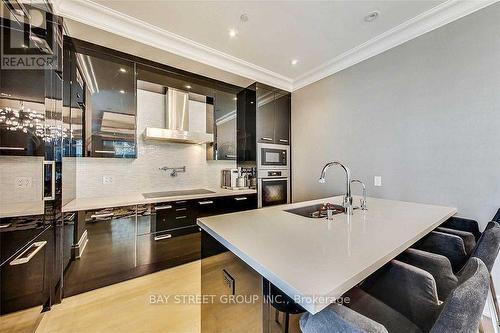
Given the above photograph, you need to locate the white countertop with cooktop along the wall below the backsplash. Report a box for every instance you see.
[63,188,257,212]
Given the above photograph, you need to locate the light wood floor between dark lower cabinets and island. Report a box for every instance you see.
[37,261,201,333]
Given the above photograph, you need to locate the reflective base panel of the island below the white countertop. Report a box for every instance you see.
[201,230,300,333]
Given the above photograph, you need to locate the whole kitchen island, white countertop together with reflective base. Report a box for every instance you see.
[198,196,456,332]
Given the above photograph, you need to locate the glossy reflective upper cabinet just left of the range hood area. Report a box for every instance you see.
[66,40,137,158]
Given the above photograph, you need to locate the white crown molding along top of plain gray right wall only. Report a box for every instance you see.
[292,0,499,90]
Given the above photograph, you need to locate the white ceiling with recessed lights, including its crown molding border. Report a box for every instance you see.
[54,0,492,90]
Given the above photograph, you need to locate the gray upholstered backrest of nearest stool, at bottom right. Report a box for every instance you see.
[431,258,490,333]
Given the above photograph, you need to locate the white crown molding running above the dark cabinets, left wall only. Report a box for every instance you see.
[54,0,293,91]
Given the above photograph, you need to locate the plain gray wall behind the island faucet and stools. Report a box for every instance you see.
[292,4,500,225]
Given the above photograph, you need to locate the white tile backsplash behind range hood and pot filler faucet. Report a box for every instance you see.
[72,90,236,198]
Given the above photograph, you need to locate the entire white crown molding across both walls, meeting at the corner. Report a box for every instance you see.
[54,0,500,91]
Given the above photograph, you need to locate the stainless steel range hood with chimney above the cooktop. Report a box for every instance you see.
[144,87,214,144]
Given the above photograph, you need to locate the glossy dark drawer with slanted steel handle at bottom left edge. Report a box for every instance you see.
[0,227,54,314]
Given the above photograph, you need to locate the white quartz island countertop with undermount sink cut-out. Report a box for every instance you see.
[198,197,457,314]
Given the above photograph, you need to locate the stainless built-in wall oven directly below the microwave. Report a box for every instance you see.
[257,169,290,208]
